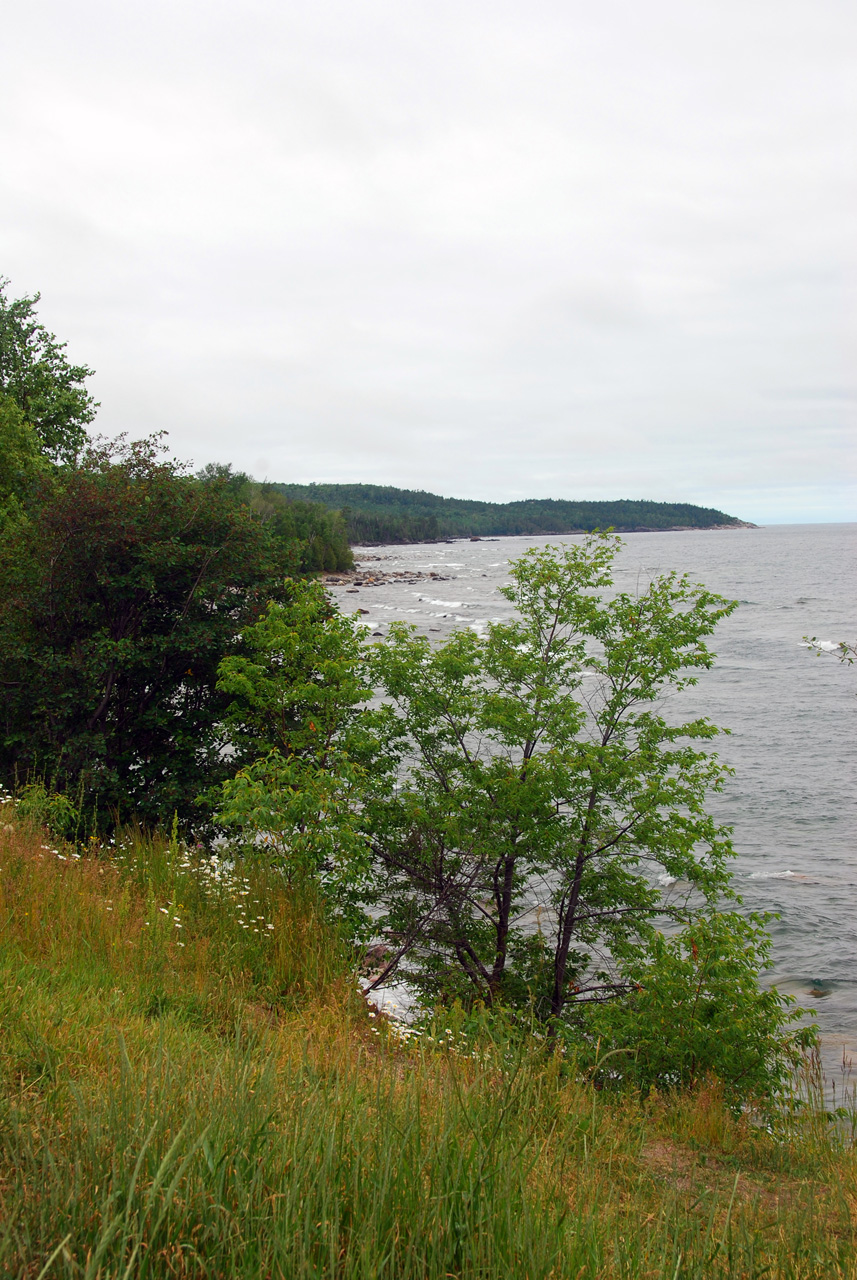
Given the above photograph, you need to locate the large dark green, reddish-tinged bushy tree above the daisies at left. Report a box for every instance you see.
[0,440,295,822]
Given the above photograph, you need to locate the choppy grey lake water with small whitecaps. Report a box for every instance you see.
[331,525,857,1070]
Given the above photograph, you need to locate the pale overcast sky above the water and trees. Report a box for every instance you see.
[0,0,857,524]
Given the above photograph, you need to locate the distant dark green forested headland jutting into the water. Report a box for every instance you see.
[267,484,746,545]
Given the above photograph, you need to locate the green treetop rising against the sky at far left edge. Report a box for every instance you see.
[0,276,98,463]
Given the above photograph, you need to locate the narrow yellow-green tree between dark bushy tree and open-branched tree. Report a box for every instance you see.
[216,581,371,934]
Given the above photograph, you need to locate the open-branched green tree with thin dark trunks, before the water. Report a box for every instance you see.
[365,535,734,1021]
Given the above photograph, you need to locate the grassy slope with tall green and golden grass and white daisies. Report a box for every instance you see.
[0,805,857,1280]
